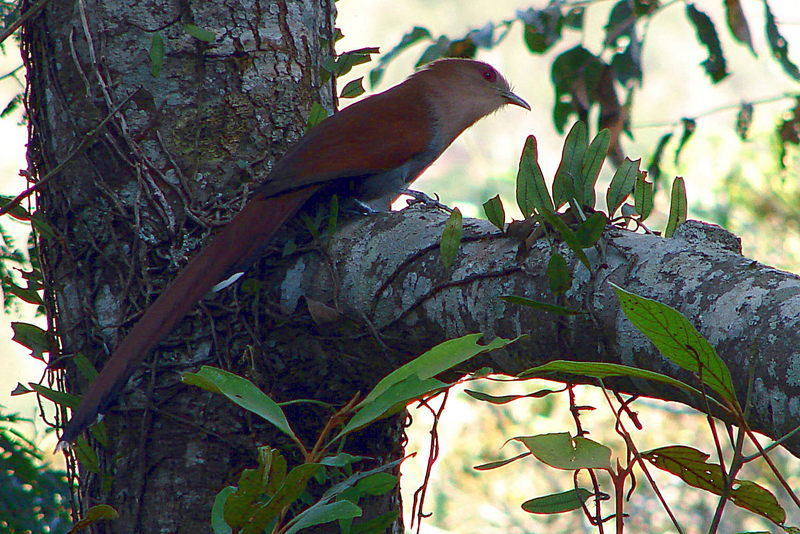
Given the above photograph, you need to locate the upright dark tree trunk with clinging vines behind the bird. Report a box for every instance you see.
[22,0,410,533]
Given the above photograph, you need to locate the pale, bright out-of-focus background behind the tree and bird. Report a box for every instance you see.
[0,0,800,533]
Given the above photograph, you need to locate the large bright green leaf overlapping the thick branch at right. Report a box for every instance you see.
[611,284,737,406]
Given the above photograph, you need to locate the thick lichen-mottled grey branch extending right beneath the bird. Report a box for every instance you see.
[274,209,800,456]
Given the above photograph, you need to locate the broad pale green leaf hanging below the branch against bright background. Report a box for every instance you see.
[513,432,611,471]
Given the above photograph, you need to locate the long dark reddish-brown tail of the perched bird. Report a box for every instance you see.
[56,186,318,450]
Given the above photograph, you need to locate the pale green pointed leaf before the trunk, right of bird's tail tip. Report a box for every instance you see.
[181,365,300,443]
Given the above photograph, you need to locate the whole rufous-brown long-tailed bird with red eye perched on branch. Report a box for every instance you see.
[58,59,530,449]
